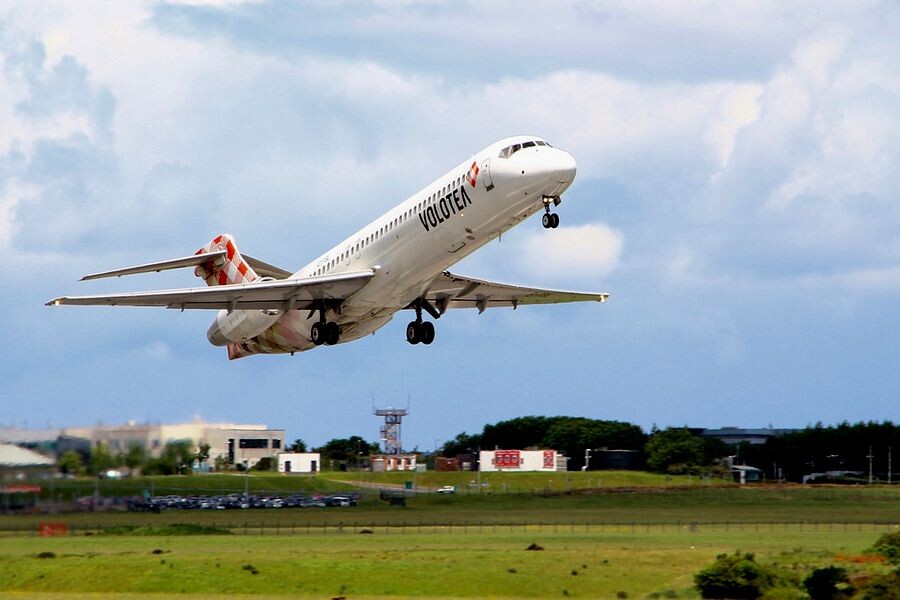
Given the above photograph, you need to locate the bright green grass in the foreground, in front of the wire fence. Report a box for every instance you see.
[0,525,884,598]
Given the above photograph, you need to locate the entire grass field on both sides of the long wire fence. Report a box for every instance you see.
[0,486,900,600]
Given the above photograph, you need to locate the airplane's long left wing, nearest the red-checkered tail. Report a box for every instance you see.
[47,269,375,310]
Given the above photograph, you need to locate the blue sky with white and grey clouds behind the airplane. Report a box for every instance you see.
[0,0,900,450]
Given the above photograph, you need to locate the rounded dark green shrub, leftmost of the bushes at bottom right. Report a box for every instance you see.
[694,552,775,600]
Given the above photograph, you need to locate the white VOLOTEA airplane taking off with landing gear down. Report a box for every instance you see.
[47,136,608,360]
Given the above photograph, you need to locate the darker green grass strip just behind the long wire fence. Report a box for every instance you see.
[0,486,900,532]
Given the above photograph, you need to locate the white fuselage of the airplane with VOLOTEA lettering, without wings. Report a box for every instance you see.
[225,136,575,357]
